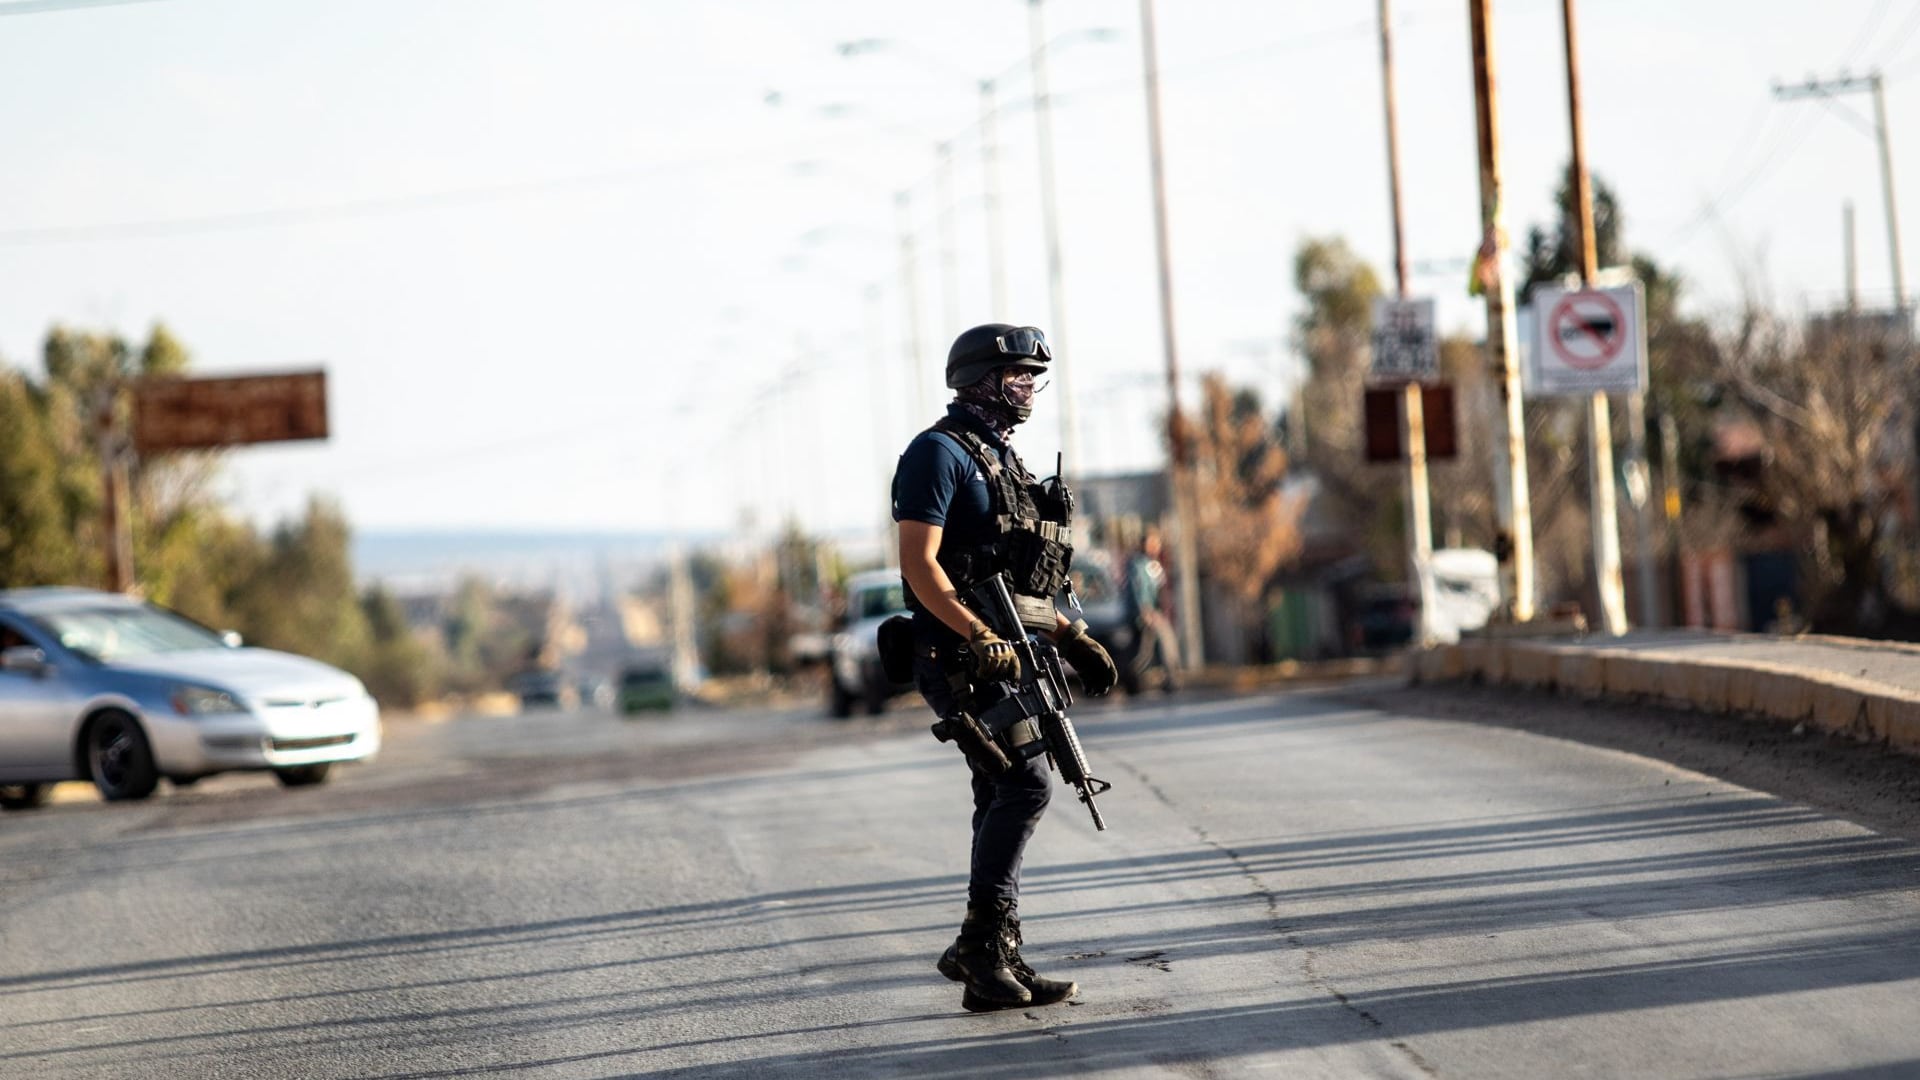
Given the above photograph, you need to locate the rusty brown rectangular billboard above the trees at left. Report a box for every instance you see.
[132,371,326,454]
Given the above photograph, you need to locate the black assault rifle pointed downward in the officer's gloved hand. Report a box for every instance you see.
[973,575,1114,832]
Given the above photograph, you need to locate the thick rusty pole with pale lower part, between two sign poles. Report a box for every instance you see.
[1467,0,1534,623]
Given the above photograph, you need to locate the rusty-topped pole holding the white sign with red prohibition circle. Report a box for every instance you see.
[1561,0,1626,636]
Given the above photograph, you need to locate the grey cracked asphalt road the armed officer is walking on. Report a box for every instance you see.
[0,694,1920,1078]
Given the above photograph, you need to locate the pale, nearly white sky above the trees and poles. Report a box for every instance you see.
[0,0,1920,530]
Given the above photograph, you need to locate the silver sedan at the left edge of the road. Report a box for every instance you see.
[0,588,380,809]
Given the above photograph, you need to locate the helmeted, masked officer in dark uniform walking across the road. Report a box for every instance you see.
[893,323,1119,1013]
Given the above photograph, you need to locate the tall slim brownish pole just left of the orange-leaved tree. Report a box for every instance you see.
[1140,0,1206,669]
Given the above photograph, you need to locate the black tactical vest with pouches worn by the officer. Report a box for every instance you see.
[906,417,1073,630]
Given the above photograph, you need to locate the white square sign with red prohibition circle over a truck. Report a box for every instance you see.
[1526,282,1647,398]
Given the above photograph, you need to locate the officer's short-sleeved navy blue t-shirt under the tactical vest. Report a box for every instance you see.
[893,405,1012,642]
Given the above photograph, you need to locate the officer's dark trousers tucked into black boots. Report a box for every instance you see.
[914,650,1054,905]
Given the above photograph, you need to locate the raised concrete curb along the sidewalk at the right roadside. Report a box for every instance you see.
[1407,638,1920,755]
